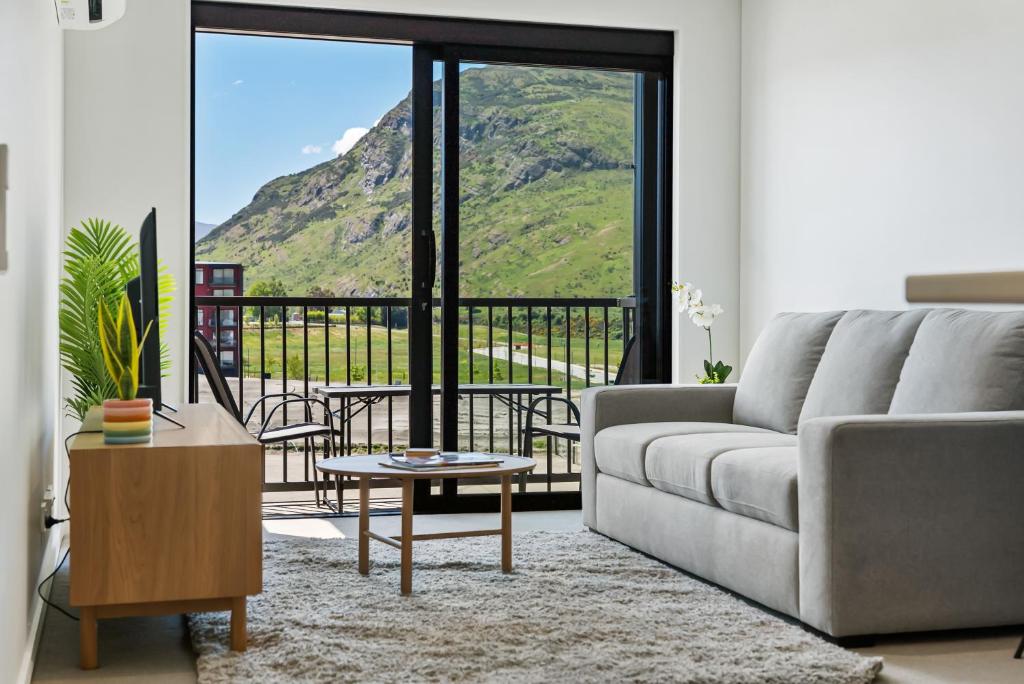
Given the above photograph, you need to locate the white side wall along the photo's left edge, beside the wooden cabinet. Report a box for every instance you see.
[0,0,61,682]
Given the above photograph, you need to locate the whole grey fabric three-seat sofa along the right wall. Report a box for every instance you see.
[582,309,1024,637]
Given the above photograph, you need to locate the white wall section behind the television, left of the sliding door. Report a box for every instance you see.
[64,0,190,402]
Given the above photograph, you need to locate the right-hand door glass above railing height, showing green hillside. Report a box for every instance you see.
[459,65,635,297]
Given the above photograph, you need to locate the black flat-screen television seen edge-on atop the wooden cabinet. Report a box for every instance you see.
[127,209,164,411]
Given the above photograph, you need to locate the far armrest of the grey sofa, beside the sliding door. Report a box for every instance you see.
[580,384,736,527]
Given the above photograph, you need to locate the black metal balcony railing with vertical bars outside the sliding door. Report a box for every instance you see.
[193,296,635,499]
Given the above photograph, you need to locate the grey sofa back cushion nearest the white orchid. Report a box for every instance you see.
[732,311,843,434]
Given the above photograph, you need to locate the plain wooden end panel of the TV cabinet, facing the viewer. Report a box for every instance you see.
[71,444,262,605]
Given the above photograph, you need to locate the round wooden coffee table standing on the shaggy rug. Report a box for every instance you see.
[316,455,537,594]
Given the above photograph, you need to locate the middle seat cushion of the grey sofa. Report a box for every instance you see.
[645,431,797,506]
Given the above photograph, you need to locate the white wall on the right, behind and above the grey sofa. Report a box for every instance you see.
[740,0,1024,356]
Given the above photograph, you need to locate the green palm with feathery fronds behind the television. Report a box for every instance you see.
[59,219,174,420]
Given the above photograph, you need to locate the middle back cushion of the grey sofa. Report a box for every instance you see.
[800,309,928,422]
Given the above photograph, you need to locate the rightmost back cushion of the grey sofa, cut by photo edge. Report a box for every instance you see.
[889,309,1024,414]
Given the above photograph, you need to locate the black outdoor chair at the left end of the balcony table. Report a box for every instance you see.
[193,332,341,508]
